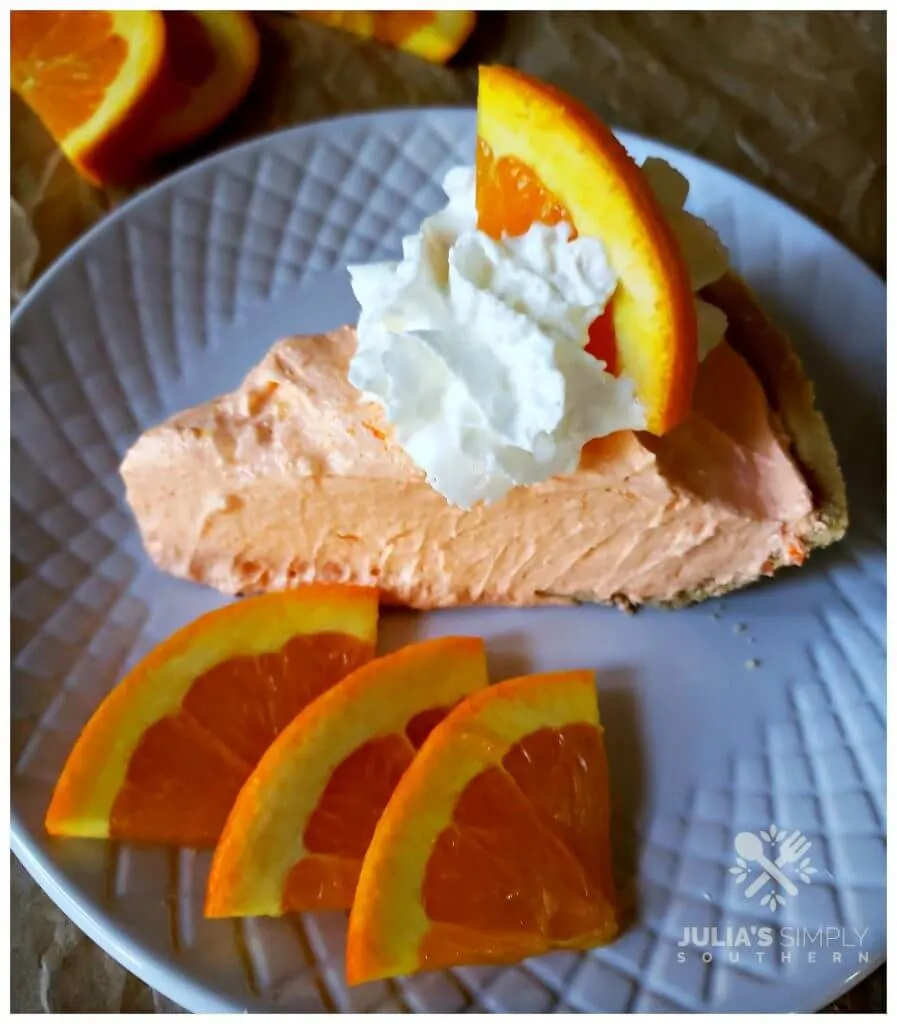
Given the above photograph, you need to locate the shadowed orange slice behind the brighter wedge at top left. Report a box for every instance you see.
[143,10,259,156]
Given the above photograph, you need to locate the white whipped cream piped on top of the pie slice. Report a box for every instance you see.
[349,161,726,508]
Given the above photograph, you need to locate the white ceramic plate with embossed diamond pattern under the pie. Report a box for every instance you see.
[12,110,885,1012]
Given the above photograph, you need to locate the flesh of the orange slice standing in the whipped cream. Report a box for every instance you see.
[476,138,618,377]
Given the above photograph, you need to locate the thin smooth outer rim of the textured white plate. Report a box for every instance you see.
[10,105,887,1013]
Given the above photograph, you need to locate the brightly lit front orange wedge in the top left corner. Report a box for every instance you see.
[10,10,165,180]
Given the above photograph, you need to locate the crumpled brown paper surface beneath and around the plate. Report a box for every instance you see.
[11,12,885,1012]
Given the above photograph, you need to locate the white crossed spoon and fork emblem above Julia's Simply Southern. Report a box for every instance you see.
[729,824,816,910]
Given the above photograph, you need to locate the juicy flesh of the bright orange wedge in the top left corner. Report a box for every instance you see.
[10,10,128,138]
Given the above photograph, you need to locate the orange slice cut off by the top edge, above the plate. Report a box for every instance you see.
[297,10,476,63]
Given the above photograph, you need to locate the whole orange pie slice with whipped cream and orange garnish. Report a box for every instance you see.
[122,68,847,608]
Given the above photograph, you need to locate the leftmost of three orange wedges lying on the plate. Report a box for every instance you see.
[45,585,378,847]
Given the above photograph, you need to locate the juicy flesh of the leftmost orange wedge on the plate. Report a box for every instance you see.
[110,633,374,846]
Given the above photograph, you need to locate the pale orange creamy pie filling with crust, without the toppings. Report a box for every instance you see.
[122,280,845,608]
